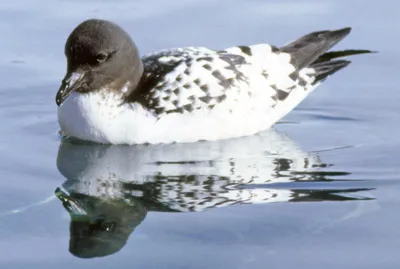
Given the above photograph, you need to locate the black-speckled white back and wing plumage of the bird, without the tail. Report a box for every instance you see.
[127,44,315,117]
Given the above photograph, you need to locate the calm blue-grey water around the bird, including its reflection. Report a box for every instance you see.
[0,0,400,269]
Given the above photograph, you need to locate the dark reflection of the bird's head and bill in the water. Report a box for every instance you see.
[56,189,147,258]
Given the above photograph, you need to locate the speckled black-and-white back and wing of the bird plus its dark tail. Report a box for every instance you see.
[128,28,370,119]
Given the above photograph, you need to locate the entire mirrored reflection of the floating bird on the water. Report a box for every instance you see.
[56,130,369,258]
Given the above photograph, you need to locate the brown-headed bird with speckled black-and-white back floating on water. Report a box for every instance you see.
[56,19,372,145]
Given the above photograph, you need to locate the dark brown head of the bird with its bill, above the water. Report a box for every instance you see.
[56,19,143,106]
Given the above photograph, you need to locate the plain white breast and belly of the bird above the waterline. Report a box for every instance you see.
[58,81,318,144]
